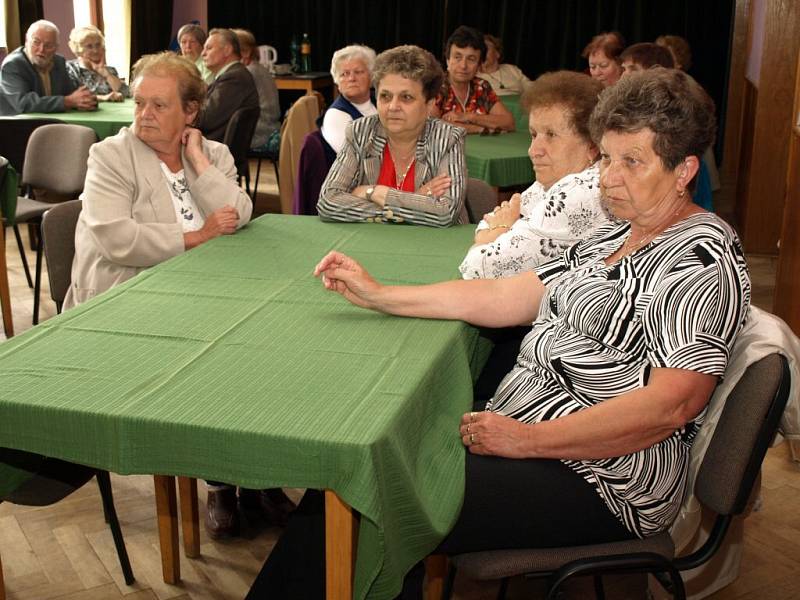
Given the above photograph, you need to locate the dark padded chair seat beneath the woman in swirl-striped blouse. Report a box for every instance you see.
[451,533,675,579]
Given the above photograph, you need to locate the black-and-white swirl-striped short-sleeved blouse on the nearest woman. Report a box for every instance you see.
[487,213,750,537]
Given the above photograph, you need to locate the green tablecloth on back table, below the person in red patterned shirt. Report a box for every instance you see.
[464,131,536,187]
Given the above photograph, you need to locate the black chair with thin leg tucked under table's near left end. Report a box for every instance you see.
[0,448,135,597]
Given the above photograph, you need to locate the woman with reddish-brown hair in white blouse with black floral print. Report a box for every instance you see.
[459,71,609,279]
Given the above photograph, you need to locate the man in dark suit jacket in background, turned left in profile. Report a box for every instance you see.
[197,29,259,142]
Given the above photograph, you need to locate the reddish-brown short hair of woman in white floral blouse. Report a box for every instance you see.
[520,71,603,144]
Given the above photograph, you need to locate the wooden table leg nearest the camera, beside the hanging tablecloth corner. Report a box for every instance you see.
[325,490,358,600]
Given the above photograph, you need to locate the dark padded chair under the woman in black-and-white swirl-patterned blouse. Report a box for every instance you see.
[443,354,790,600]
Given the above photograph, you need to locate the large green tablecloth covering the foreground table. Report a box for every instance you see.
[0,215,487,598]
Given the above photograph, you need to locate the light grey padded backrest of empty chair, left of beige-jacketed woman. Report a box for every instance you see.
[22,123,97,198]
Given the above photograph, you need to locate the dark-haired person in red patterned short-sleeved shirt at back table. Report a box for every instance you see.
[430,25,514,133]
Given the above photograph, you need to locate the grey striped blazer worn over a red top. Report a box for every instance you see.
[317,115,467,227]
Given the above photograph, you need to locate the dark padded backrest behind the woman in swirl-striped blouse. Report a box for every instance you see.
[695,354,790,515]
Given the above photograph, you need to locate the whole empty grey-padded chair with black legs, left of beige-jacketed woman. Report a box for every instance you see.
[6,123,97,325]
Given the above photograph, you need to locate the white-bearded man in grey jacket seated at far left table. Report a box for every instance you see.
[0,20,97,116]
